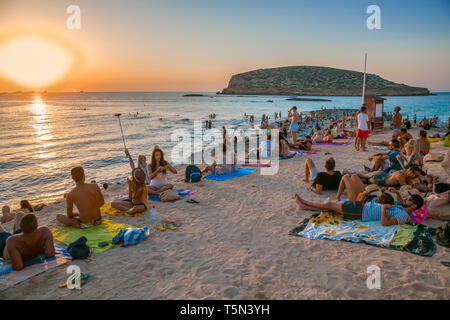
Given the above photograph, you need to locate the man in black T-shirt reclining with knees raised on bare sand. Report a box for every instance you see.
[303,158,342,194]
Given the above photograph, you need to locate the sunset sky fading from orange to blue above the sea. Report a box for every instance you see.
[0,0,450,92]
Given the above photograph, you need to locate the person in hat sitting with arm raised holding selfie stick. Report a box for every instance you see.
[111,149,148,214]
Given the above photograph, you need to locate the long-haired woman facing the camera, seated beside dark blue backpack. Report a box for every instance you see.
[148,148,177,195]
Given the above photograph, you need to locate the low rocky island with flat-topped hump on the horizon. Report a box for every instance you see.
[220,66,430,96]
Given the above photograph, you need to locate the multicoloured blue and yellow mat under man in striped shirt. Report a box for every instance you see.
[289,213,436,257]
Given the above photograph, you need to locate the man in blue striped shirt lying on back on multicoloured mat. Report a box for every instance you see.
[294,193,423,226]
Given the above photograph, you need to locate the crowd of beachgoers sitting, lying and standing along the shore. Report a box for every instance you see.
[0,105,450,270]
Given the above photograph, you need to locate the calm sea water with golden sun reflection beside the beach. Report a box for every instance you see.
[0,92,450,206]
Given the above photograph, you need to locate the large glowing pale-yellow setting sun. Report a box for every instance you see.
[0,35,74,88]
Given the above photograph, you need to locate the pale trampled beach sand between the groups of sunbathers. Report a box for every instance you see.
[0,128,450,300]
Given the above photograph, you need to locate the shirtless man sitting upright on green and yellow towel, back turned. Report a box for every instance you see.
[56,167,105,228]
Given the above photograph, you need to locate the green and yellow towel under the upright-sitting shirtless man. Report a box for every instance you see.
[51,219,133,253]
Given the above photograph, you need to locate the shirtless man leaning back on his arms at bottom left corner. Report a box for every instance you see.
[0,213,55,270]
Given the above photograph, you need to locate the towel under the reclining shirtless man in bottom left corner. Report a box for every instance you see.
[0,245,72,291]
